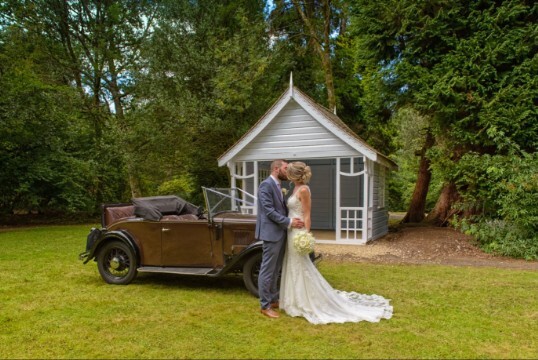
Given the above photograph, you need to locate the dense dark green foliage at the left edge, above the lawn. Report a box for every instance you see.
[0,27,119,213]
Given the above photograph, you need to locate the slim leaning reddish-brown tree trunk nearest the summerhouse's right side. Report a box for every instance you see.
[402,130,435,223]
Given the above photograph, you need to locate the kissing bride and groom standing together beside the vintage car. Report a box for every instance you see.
[256,160,392,324]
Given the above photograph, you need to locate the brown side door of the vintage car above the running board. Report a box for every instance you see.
[161,220,212,267]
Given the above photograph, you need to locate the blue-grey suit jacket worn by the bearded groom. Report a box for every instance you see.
[256,176,291,242]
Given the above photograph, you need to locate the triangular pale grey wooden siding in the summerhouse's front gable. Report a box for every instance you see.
[235,99,360,161]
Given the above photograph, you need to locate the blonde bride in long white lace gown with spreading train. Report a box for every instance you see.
[279,162,392,324]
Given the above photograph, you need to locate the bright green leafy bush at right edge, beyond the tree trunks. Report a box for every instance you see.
[456,153,538,260]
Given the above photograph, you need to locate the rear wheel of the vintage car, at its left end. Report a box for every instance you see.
[97,241,137,285]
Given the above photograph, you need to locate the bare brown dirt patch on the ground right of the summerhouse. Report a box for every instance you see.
[316,226,538,270]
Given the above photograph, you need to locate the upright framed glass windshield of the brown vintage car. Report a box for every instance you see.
[202,187,256,219]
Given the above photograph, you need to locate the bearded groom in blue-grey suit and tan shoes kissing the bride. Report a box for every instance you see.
[256,160,304,318]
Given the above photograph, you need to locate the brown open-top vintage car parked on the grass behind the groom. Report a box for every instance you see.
[79,188,262,296]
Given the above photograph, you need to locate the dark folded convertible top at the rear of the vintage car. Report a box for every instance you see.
[131,195,202,221]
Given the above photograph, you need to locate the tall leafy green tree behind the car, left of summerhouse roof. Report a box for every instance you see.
[136,0,280,202]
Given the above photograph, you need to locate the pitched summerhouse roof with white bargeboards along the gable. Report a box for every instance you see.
[218,84,398,170]
